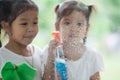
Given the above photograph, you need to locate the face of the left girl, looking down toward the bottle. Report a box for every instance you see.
[8,10,38,45]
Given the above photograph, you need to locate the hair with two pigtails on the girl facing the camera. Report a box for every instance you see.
[55,0,93,22]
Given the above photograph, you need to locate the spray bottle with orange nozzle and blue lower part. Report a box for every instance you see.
[52,31,68,80]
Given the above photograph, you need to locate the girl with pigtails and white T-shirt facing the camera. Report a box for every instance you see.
[52,0,103,80]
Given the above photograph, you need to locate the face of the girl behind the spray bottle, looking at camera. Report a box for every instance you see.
[59,10,88,42]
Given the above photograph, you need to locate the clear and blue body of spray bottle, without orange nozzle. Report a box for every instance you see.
[55,46,68,80]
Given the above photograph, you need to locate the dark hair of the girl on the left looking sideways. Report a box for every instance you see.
[0,0,38,46]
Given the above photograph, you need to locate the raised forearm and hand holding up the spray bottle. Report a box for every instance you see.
[42,39,58,80]
